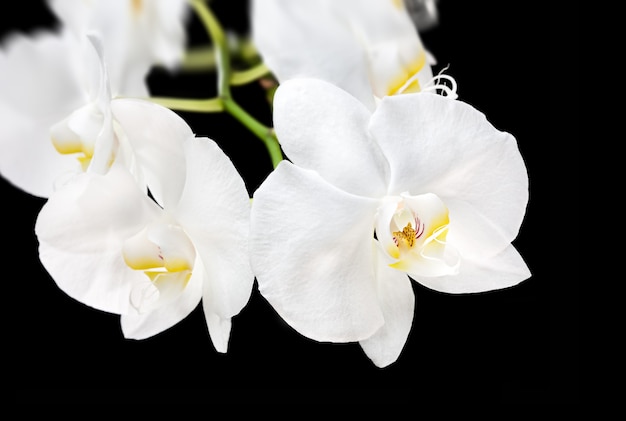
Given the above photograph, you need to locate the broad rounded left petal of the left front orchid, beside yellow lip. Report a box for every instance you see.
[35,162,160,314]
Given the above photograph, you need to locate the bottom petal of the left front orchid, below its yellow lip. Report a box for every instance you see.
[121,264,203,339]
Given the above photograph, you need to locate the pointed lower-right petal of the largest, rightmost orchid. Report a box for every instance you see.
[409,246,531,293]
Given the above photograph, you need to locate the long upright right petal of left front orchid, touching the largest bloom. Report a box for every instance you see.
[172,138,254,319]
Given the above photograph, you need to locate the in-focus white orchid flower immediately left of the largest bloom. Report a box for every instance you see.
[35,99,254,352]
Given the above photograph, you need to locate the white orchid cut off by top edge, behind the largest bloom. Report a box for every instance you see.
[251,0,434,108]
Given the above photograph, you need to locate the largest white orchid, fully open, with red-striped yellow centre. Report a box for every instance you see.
[251,79,530,367]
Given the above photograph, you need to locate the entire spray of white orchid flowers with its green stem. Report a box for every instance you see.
[0,0,531,368]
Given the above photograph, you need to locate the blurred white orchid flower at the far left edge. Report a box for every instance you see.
[0,27,173,198]
